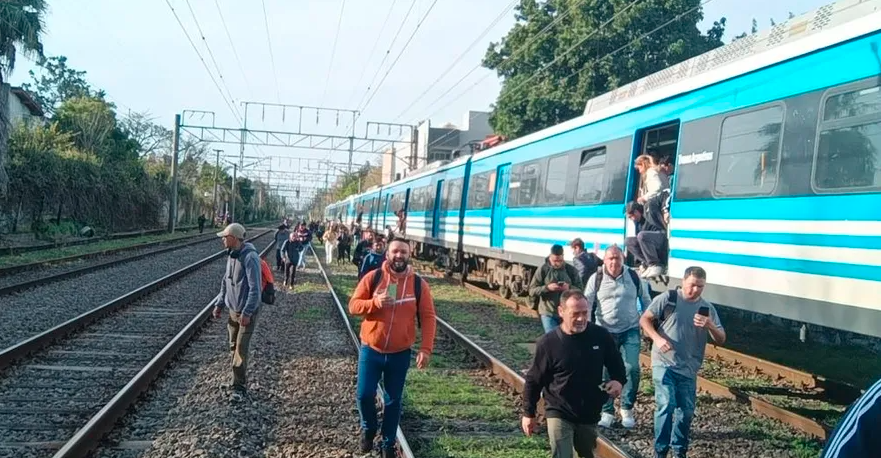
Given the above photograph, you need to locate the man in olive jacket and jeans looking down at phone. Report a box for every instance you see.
[529,245,584,333]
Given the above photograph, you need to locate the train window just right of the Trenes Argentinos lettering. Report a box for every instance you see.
[714,105,784,197]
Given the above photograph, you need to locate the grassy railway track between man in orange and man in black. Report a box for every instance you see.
[316,247,631,458]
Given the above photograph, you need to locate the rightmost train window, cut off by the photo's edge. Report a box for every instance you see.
[813,83,881,190]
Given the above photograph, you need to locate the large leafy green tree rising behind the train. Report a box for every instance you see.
[483,0,725,138]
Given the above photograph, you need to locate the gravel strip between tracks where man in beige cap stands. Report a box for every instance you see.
[94,245,370,458]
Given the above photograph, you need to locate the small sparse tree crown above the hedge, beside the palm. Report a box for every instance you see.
[22,56,106,116]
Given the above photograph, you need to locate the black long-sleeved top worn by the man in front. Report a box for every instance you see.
[523,324,627,425]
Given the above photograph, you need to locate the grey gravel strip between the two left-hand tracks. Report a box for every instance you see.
[0,232,268,354]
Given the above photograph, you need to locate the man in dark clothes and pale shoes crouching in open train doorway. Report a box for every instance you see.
[624,201,668,278]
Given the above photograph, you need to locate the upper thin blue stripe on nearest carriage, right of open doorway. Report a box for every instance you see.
[672,231,881,250]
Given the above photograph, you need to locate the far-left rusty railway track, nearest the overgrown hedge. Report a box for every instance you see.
[0,234,216,296]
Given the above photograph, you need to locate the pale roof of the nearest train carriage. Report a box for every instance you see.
[472,0,881,162]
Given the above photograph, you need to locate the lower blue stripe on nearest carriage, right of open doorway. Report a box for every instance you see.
[670,249,881,282]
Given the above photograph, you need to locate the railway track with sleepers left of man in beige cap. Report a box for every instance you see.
[0,234,272,457]
